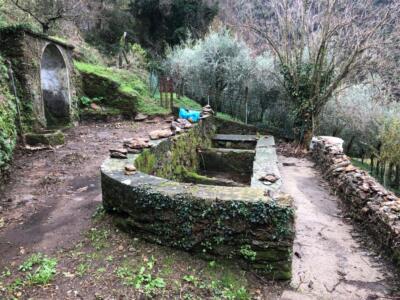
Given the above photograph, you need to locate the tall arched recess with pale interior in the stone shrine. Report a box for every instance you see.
[40,44,71,127]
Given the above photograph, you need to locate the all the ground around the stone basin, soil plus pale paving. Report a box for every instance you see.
[0,119,396,299]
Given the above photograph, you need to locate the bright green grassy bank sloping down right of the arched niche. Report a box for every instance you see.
[75,61,170,115]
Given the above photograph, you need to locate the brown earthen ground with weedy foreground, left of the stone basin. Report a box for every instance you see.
[0,119,285,299]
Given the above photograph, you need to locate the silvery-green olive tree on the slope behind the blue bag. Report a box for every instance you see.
[165,29,254,115]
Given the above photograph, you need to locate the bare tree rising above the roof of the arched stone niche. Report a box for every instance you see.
[9,0,82,33]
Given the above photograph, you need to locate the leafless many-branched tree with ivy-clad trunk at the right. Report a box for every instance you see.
[232,0,400,146]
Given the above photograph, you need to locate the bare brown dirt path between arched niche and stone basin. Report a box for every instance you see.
[0,120,168,269]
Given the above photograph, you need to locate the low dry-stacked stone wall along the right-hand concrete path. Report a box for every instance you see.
[312,137,400,264]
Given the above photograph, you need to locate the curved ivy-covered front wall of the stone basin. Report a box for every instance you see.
[101,118,294,280]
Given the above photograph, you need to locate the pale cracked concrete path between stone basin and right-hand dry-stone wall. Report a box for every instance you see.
[280,156,399,299]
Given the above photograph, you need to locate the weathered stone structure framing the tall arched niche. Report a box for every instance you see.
[0,26,79,132]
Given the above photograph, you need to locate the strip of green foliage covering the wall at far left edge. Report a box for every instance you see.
[0,56,17,182]
